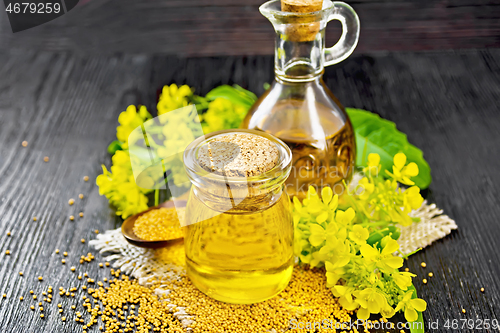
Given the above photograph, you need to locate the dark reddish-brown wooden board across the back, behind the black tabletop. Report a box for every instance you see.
[0,0,500,57]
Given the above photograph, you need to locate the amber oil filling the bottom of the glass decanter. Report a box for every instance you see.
[242,99,356,199]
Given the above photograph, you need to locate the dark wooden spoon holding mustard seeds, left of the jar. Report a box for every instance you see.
[122,200,186,249]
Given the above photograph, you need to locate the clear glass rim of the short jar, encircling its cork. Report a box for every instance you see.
[183,129,292,185]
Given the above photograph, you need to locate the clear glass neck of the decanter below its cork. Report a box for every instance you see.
[274,29,325,82]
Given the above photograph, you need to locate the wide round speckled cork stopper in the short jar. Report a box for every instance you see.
[198,133,279,177]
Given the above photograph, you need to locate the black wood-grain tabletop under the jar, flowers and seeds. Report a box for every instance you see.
[0,49,500,333]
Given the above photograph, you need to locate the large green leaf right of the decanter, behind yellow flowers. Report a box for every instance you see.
[346,108,432,189]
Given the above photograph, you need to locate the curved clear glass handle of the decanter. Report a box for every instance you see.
[325,2,359,66]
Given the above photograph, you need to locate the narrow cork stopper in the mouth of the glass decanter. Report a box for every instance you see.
[281,0,323,42]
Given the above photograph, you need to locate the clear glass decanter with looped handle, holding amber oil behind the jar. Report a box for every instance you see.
[242,0,359,198]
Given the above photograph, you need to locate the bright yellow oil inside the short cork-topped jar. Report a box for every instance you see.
[184,192,293,304]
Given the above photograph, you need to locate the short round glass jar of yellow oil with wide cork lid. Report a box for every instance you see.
[184,130,293,304]
